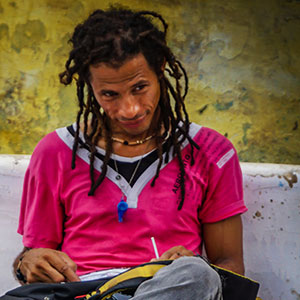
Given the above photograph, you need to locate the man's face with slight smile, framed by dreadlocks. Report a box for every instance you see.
[90,54,160,139]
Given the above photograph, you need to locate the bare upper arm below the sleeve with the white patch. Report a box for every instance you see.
[203,215,244,275]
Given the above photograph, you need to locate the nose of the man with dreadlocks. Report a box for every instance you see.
[119,94,141,121]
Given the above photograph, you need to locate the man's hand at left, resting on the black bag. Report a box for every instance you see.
[20,248,80,283]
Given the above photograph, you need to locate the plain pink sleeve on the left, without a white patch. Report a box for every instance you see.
[18,133,64,249]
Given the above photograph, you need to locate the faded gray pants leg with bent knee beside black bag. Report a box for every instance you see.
[131,256,222,300]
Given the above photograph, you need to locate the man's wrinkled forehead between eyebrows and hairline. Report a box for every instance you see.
[89,54,156,84]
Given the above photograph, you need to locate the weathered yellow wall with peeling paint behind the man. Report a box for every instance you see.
[0,0,300,164]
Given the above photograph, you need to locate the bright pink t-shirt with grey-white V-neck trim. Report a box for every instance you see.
[18,124,247,275]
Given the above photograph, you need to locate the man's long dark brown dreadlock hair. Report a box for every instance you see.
[59,7,198,210]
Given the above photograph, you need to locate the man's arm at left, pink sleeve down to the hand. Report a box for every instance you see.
[13,132,78,283]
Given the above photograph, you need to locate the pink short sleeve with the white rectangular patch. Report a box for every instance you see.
[199,137,247,223]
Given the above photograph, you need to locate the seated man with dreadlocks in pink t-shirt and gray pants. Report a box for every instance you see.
[14,8,246,299]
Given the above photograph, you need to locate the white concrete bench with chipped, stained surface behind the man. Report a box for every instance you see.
[0,155,300,300]
